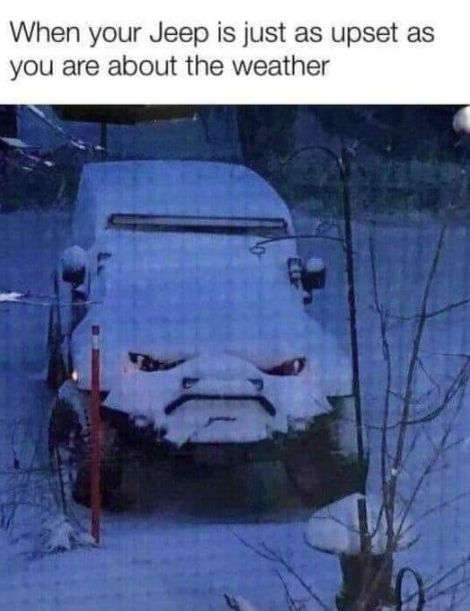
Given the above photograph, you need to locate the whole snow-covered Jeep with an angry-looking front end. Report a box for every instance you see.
[48,161,361,506]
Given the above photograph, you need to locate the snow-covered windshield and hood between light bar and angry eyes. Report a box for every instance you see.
[75,234,312,366]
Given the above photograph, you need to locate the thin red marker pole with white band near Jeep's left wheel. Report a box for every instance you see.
[90,325,101,543]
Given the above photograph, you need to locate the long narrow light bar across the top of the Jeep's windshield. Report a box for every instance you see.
[107,214,288,237]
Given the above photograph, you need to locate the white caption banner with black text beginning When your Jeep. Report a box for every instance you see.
[0,0,470,104]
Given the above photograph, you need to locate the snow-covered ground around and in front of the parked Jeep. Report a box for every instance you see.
[0,212,470,611]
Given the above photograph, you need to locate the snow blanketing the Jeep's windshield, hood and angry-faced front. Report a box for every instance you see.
[72,230,350,443]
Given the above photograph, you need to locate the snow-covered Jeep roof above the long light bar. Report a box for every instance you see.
[74,160,292,248]
